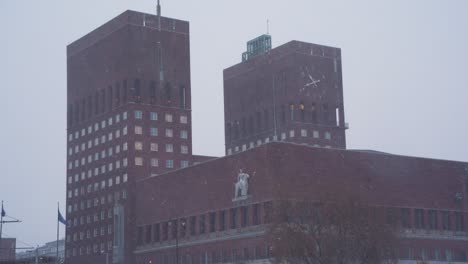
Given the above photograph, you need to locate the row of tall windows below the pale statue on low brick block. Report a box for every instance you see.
[137,202,272,245]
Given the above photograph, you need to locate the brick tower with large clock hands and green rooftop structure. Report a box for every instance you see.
[224,35,347,155]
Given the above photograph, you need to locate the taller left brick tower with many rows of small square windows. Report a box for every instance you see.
[66,8,204,263]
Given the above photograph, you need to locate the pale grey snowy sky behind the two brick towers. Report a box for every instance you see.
[0,0,468,246]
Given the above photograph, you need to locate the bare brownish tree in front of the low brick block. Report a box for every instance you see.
[268,198,398,264]
